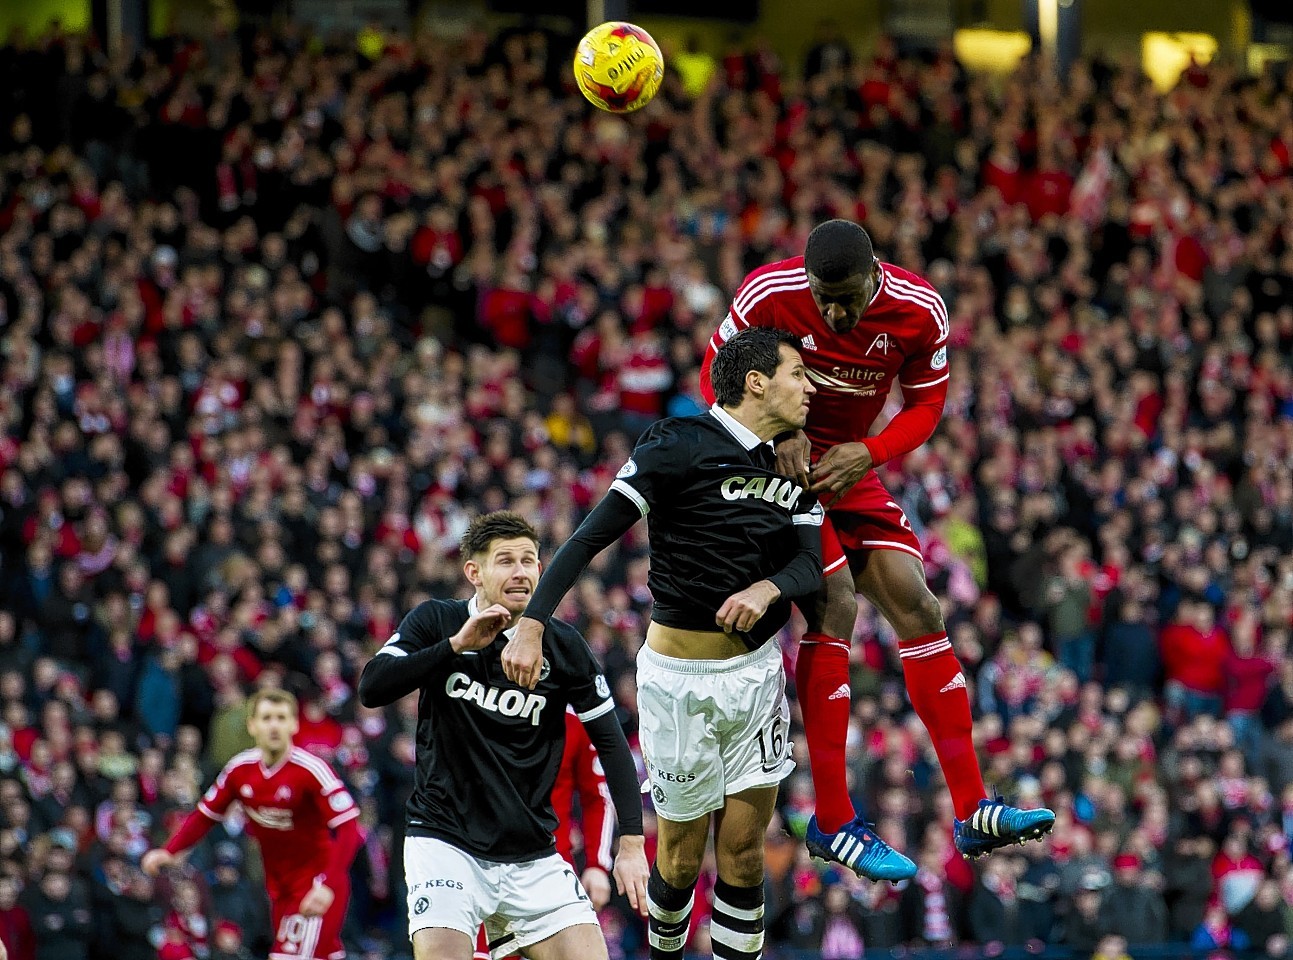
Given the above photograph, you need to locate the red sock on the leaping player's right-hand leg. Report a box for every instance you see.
[905,631,988,820]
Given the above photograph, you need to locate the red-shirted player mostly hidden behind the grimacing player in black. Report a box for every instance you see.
[475,706,615,960]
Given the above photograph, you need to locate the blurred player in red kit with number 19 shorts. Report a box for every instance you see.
[142,690,363,960]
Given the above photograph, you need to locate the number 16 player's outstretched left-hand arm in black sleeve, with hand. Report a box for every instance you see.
[502,492,641,690]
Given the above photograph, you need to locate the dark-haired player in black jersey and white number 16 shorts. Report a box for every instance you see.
[503,327,824,960]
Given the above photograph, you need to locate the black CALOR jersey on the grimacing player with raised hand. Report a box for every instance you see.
[379,598,614,863]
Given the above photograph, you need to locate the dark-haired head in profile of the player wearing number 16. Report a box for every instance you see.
[710,326,817,432]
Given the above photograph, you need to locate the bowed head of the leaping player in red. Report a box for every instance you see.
[804,220,881,334]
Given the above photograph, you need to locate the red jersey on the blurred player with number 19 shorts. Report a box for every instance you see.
[198,747,359,899]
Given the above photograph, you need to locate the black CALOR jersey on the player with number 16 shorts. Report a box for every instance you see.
[610,408,825,646]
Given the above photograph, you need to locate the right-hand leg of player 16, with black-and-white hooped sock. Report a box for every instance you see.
[710,787,777,960]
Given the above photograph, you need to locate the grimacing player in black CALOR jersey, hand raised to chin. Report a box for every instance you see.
[359,511,648,960]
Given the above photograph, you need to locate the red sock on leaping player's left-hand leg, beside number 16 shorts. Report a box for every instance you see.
[795,633,853,833]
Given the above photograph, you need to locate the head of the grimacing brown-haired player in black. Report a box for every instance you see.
[459,510,542,616]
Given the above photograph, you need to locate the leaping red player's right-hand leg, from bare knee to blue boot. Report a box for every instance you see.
[855,550,1055,856]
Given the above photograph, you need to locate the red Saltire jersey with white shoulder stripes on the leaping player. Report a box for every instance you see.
[701,256,950,462]
